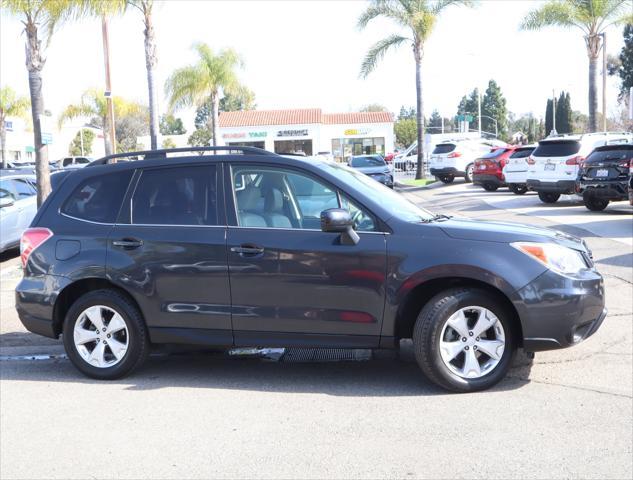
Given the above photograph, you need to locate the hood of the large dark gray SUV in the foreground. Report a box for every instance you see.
[439,218,589,253]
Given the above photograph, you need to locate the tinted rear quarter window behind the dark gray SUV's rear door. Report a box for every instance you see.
[62,170,132,223]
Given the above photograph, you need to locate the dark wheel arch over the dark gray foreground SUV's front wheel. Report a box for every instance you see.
[393,277,523,346]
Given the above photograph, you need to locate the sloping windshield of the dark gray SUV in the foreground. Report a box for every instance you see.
[319,162,435,223]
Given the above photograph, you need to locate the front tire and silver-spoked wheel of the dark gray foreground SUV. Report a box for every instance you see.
[413,288,516,392]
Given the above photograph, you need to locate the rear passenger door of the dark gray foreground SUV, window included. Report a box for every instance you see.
[107,165,233,345]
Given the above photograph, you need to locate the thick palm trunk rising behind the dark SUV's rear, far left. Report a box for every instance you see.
[25,22,51,207]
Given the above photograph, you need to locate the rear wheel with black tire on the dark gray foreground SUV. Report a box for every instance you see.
[63,290,149,380]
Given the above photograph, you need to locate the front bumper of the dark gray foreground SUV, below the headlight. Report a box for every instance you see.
[513,270,607,352]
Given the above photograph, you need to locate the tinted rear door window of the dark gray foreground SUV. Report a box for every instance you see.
[132,165,218,225]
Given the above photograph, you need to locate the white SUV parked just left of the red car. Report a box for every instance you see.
[429,140,491,183]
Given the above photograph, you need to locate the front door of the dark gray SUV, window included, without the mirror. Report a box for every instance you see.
[226,164,386,347]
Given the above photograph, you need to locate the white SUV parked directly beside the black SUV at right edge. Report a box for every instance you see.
[526,132,633,203]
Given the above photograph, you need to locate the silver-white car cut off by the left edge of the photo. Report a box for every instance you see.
[0,172,37,252]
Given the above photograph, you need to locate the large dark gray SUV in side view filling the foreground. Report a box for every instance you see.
[16,147,606,391]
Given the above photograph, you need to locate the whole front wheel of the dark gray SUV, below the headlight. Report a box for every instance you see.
[413,288,516,392]
